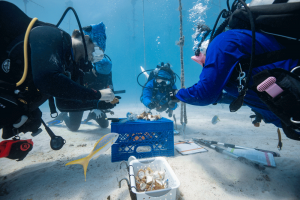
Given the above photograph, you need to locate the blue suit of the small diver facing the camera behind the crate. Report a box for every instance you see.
[141,79,177,110]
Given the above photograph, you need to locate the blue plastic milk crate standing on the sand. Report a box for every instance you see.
[111,118,174,162]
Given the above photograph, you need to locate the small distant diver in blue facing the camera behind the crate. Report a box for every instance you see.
[141,62,177,117]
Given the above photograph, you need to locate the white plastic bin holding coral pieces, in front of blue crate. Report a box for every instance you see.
[129,157,180,200]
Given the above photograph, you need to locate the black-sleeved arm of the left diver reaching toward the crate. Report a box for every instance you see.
[29,26,101,100]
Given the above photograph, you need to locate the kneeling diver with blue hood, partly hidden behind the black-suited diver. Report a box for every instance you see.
[48,22,113,131]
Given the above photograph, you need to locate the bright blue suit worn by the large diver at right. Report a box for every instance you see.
[176,29,298,128]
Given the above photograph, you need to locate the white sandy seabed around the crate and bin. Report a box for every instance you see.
[0,105,300,200]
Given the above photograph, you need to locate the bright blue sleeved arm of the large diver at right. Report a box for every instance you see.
[176,33,245,106]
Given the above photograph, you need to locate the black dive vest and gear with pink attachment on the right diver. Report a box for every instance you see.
[207,0,300,140]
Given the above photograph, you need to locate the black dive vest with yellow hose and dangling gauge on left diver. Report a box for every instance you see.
[0,1,86,150]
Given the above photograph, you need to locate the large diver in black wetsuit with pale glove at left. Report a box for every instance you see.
[0,1,115,143]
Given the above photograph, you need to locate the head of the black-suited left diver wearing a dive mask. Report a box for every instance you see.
[72,30,94,63]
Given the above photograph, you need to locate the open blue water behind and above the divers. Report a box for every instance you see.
[10,0,226,108]
